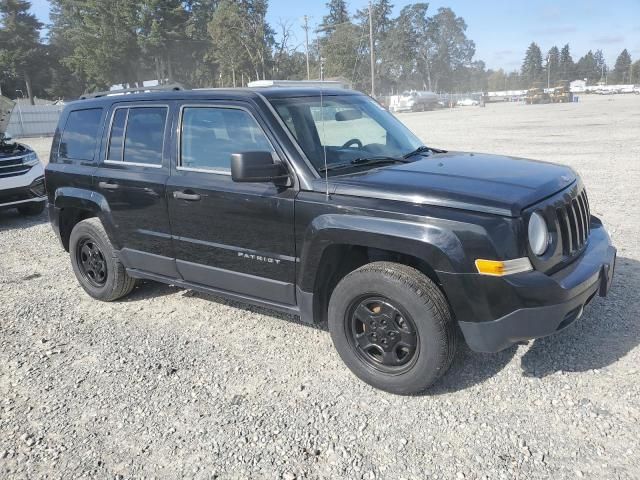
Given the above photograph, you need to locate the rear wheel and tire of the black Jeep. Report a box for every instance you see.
[69,218,136,302]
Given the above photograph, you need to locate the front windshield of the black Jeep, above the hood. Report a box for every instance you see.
[271,95,422,174]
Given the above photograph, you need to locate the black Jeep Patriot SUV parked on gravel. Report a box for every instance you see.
[46,88,616,394]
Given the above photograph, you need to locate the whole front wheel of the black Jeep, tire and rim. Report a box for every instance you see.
[329,262,457,395]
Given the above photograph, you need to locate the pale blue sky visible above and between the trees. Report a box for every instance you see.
[27,0,640,71]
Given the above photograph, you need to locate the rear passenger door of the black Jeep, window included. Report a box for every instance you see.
[94,103,178,277]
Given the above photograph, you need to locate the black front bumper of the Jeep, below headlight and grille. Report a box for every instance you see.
[454,221,616,352]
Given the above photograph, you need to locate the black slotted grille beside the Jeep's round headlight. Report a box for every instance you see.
[556,189,591,255]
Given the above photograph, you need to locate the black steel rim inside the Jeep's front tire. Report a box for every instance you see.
[345,296,419,373]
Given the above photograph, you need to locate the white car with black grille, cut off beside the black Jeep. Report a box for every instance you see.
[0,97,46,215]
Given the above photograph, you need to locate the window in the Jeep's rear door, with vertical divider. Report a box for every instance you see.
[107,107,168,166]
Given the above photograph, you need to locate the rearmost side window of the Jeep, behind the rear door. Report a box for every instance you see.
[58,108,102,161]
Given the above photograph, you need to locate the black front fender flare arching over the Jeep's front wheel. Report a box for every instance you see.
[298,214,470,292]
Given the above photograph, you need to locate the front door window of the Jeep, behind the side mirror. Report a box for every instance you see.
[180,107,273,172]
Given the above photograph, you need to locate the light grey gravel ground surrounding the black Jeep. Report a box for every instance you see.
[0,96,640,479]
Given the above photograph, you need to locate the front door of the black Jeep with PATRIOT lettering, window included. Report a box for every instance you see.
[167,103,296,305]
